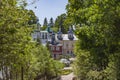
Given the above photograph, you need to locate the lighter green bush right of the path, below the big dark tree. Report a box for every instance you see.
[73,47,92,79]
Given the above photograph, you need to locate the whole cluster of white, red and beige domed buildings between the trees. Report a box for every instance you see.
[32,26,78,59]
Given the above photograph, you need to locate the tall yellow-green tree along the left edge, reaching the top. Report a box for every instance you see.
[0,0,34,80]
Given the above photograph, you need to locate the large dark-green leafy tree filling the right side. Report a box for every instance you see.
[66,0,120,80]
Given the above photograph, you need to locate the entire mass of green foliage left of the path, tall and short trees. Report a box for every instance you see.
[0,0,62,80]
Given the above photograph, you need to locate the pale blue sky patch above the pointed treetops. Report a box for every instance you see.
[26,0,68,25]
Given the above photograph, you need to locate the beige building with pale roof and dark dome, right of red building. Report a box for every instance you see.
[58,28,78,57]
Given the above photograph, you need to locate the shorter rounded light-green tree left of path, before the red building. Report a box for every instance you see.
[33,44,63,80]
